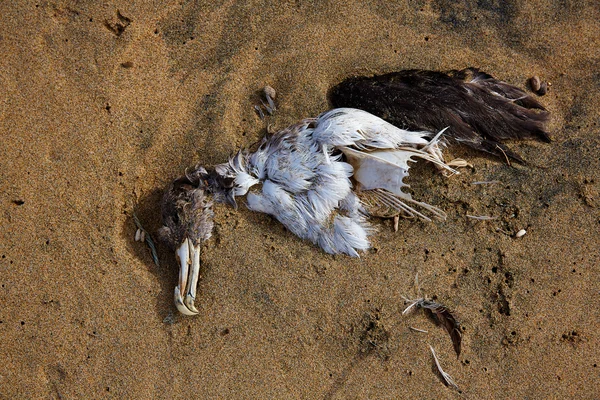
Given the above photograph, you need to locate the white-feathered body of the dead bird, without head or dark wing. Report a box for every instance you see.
[236,108,450,257]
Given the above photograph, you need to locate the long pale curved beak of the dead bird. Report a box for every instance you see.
[174,238,200,315]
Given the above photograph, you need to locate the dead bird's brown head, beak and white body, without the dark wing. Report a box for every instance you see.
[160,69,548,315]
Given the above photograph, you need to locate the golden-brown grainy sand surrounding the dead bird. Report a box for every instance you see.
[0,0,600,399]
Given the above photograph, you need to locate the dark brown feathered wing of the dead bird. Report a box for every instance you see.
[329,68,550,162]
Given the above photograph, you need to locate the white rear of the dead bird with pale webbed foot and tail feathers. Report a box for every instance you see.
[312,108,455,220]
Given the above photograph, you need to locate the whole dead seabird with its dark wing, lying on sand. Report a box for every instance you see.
[160,70,548,315]
